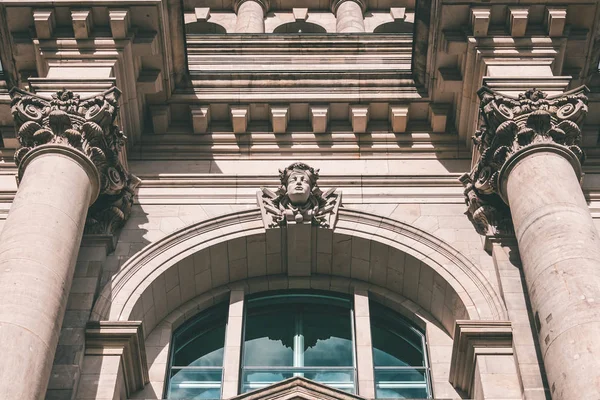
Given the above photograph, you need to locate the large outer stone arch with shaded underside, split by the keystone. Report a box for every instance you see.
[92,209,506,334]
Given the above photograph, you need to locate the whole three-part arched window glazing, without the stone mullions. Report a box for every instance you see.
[167,291,431,399]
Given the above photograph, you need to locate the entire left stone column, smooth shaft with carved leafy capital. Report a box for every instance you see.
[0,88,137,400]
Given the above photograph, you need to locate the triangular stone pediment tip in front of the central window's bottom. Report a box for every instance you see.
[232,377,365,400]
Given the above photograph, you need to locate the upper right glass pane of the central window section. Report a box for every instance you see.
[302,308,353,367]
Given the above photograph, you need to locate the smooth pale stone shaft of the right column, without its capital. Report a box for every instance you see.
[504,146,600,400]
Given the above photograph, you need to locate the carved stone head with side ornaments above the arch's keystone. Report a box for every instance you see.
[256,162,342,229]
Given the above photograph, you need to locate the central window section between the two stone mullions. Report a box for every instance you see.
[241,294,355,393]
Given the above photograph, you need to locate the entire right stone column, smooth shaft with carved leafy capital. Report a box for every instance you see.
[463,87,600,400]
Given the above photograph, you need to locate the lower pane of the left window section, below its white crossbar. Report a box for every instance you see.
[168,369,222,399]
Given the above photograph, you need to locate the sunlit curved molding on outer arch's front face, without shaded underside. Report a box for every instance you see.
[92,209,506,332]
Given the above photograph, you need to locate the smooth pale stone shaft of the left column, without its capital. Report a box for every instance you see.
[0,145,98,400]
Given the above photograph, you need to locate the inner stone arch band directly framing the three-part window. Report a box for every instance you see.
[131,275,460,399]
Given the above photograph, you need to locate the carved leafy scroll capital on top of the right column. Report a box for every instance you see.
[460,86,588,235]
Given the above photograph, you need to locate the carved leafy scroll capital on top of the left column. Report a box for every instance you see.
[10,87,140,234]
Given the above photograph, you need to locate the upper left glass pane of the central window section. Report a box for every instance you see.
[244,309,295,366]
